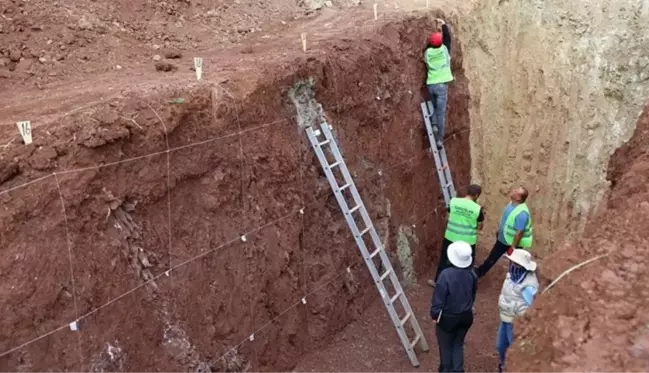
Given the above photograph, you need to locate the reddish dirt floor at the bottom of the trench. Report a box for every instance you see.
[291,258,506,373]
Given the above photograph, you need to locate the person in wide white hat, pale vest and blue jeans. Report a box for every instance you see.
[496,249,539,373]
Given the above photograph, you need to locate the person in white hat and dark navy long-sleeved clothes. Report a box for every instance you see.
[430,241,478,373]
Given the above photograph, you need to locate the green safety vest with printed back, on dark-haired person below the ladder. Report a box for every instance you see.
[444,197,480,245]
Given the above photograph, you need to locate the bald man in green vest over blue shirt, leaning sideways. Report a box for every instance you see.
[476,186,533,277]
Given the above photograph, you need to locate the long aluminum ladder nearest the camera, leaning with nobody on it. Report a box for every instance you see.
[306,122,428,367]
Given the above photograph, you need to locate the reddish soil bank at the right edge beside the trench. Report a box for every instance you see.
[509,101,649,373]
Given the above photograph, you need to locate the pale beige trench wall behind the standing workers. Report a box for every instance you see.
[457,0,649,255]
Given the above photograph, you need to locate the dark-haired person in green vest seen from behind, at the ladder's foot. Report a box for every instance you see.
[427,184,484,286]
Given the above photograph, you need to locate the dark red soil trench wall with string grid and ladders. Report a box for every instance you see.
[0,19,470,372]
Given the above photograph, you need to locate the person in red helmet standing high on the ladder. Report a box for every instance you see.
[424,18,453,149]
